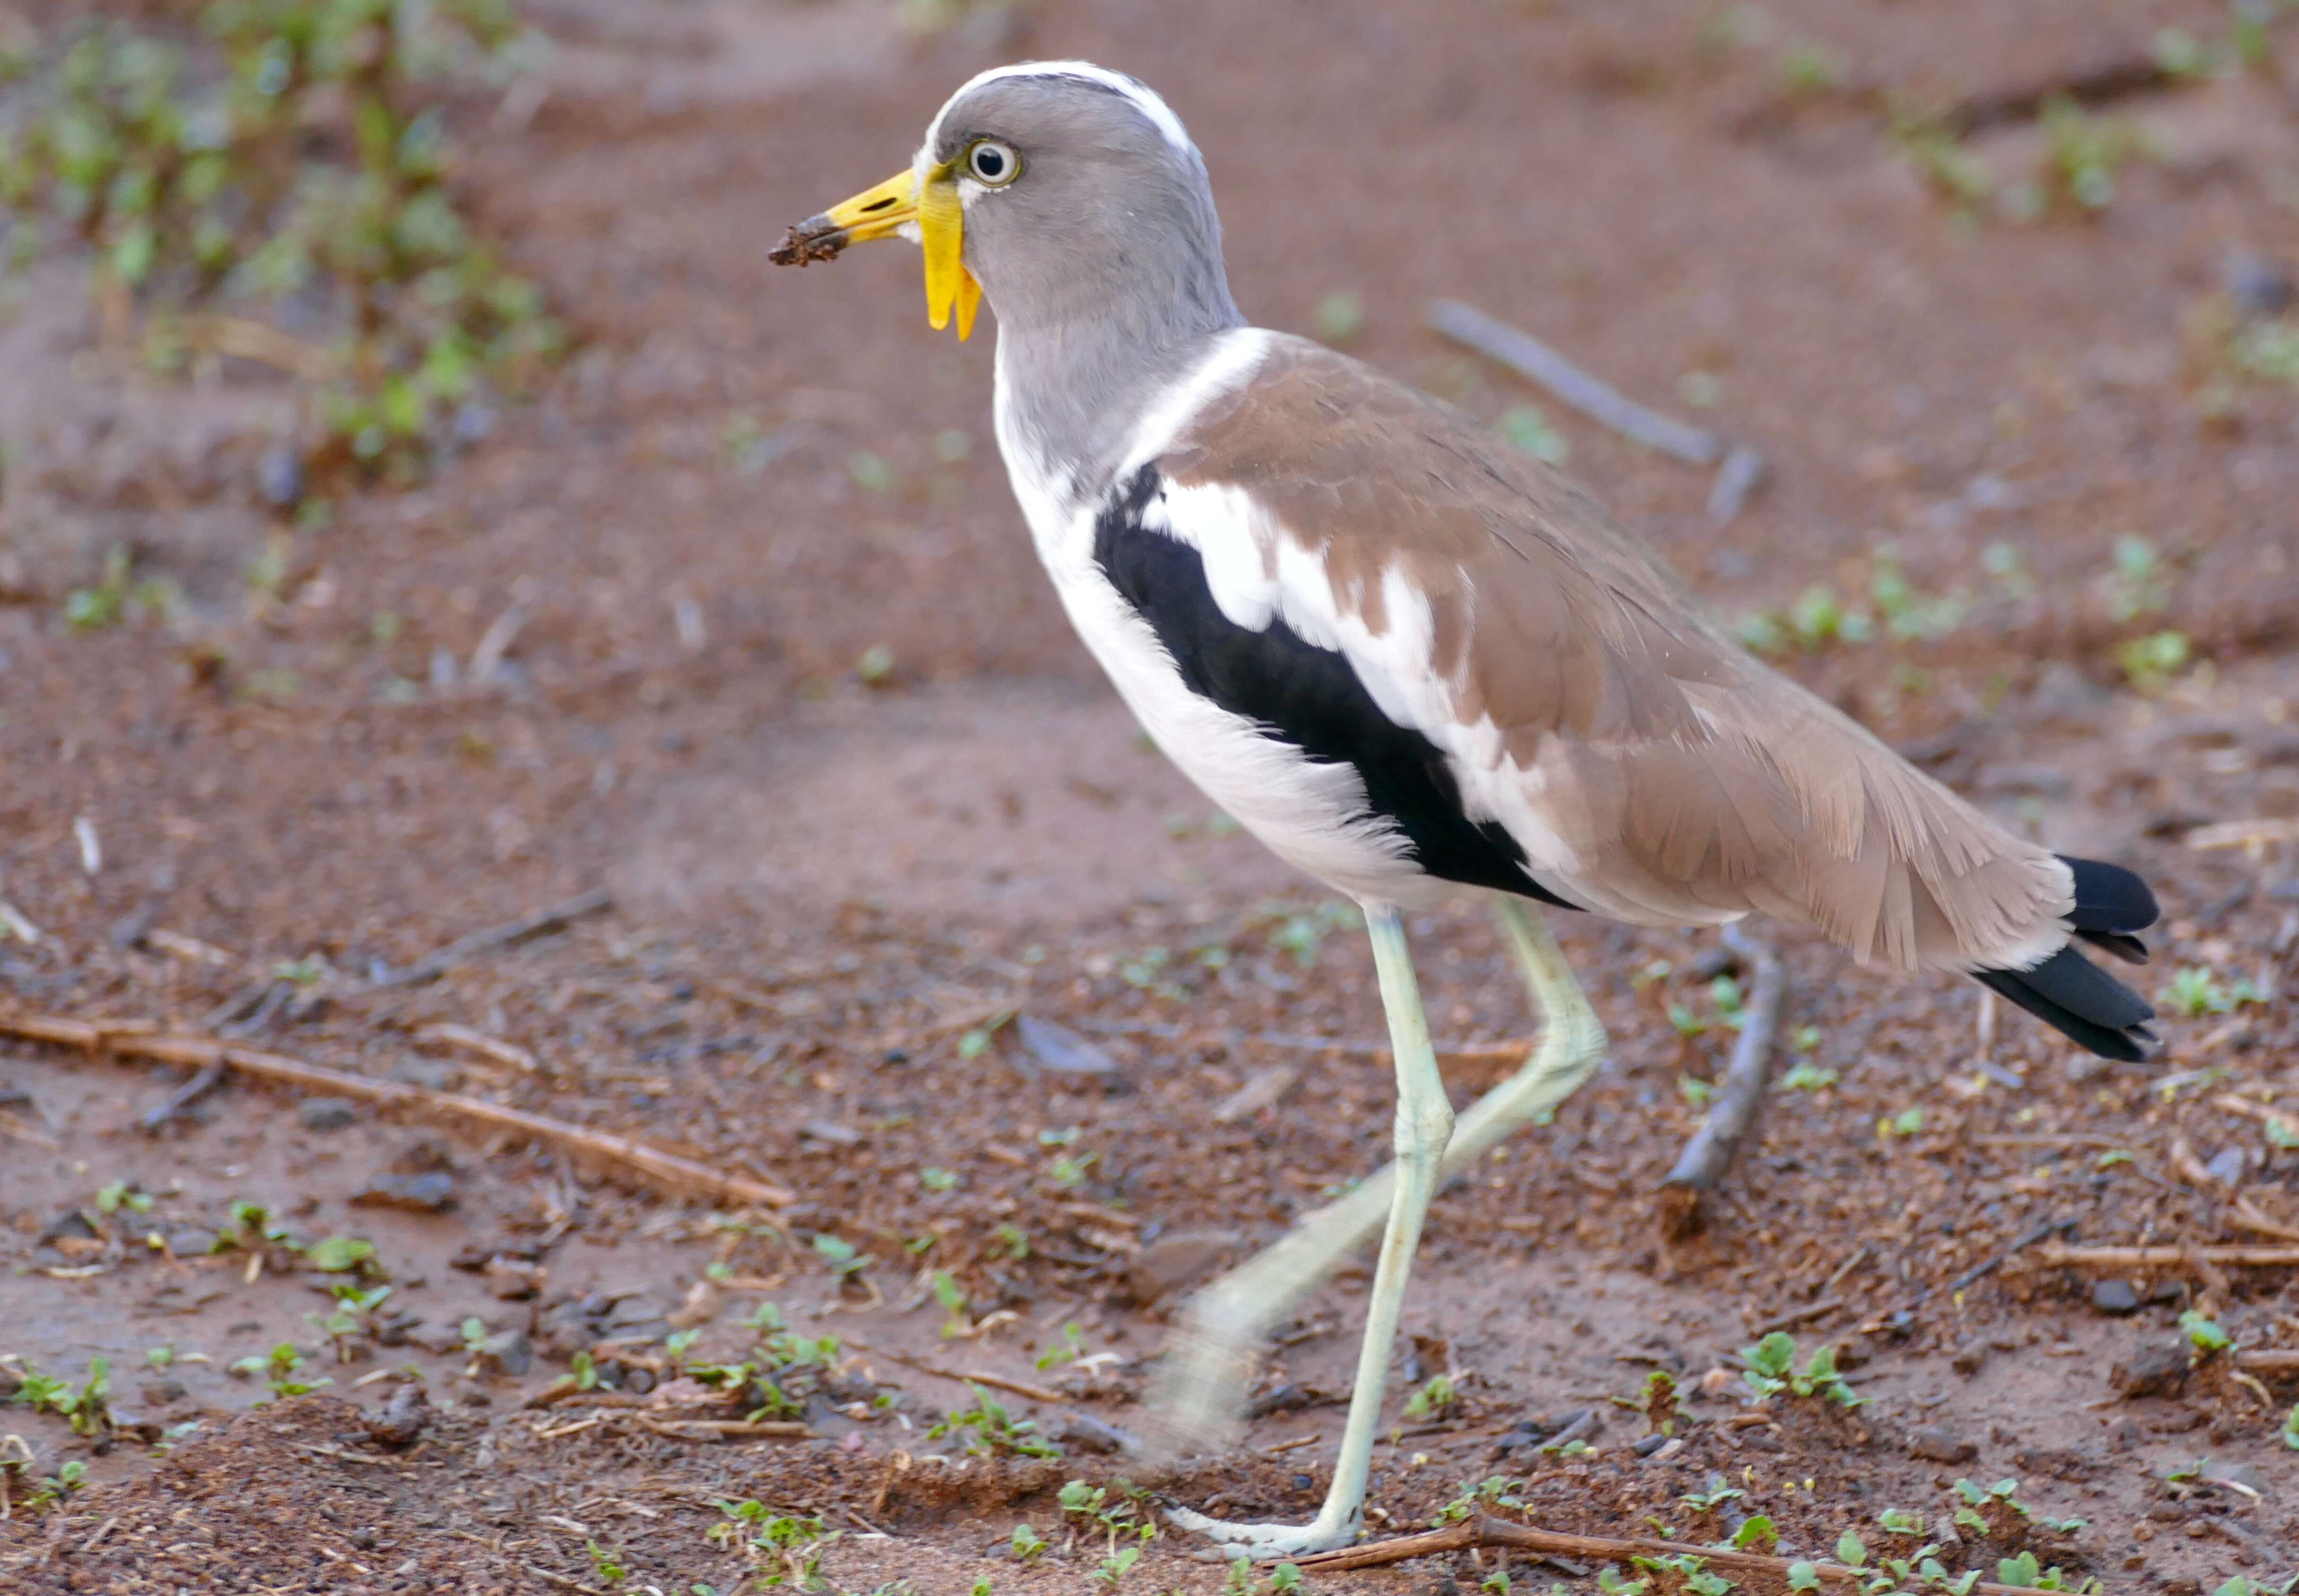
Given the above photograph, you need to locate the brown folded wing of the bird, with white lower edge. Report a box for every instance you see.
[1161,338,2074,968]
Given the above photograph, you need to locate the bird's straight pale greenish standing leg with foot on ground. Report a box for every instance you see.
[1173,904,1453,1557]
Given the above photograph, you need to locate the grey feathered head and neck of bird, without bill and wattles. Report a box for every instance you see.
[924,64,1244,501]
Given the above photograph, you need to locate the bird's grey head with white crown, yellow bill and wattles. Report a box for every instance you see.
[773,62,1235,338]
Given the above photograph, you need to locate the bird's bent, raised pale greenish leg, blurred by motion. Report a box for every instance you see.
[1152,897,1605,1563]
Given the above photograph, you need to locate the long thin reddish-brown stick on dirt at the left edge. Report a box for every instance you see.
[0,1014,795,1207]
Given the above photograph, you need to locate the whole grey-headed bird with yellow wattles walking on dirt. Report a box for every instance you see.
[773,62,2157,1561]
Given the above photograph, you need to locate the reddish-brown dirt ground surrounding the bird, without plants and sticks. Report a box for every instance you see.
[0,0,2299,1596]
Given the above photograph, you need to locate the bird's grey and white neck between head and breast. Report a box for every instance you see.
[998,278,1244,520]
